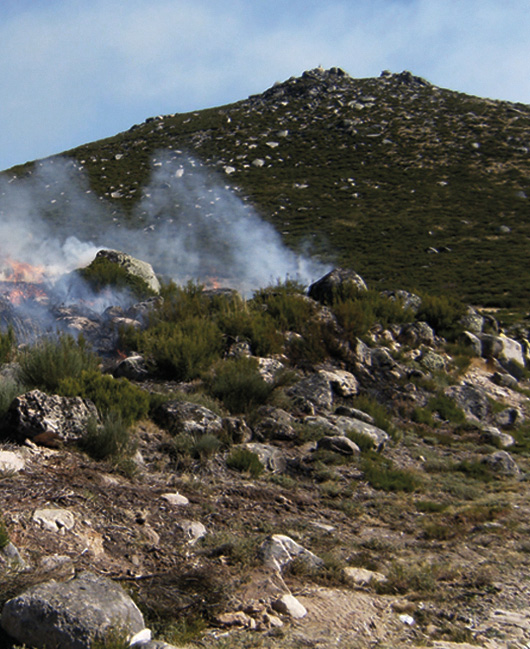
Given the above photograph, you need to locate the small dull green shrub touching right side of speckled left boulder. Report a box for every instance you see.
[79,412,133,460]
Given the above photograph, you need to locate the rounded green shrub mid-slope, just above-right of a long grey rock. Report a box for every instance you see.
[207,357,275,413]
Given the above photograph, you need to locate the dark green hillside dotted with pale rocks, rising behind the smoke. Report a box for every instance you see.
[7,68,530,310]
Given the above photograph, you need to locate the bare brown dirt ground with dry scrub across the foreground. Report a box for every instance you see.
[0,374,530,649]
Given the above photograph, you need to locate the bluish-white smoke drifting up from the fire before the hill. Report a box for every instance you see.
[0,152,327,296]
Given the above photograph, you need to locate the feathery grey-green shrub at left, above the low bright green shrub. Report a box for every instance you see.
[19,335,98,392]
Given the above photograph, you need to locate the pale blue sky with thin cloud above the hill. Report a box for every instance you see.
[0,0,530,169]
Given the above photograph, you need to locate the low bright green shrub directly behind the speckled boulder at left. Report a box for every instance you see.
[58,370,150,426]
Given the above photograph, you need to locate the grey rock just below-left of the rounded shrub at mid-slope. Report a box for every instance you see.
[153,399,223,435]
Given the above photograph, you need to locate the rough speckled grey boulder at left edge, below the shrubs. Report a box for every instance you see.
[3,390,98,445]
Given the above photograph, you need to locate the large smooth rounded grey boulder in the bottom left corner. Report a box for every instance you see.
[1,572,145,649]
